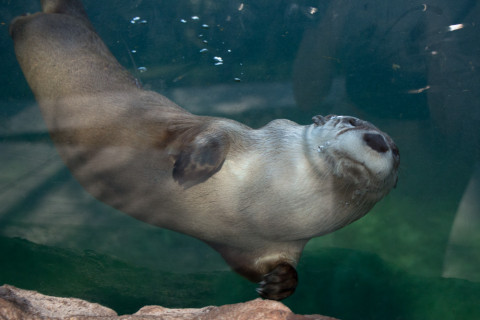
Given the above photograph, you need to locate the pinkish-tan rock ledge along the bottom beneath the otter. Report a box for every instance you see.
[0,285,335,320]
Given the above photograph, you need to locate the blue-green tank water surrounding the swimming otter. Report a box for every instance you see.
[0,0,480,320]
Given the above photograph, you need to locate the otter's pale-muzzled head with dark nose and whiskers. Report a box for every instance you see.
[308,115,400,198]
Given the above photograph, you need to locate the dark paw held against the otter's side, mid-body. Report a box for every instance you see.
[173,132,230,187]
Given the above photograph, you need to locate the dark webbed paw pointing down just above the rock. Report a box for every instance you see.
[257,262,298,300]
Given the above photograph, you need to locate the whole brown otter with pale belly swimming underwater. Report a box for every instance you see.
[10,0,399,300]
